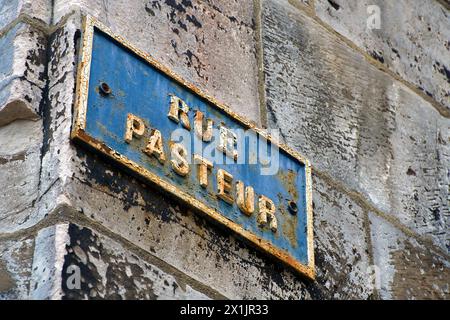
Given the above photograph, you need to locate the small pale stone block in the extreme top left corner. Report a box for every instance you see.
[0,0,52,32]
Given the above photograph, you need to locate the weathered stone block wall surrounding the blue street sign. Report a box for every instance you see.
[0,0,450,299]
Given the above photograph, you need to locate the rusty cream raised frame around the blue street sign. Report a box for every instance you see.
[71,16,315,280]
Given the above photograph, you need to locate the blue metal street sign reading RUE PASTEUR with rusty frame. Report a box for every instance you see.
[72,17,315,279]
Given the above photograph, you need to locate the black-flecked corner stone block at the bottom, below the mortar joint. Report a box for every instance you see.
[31,224,213,299]
